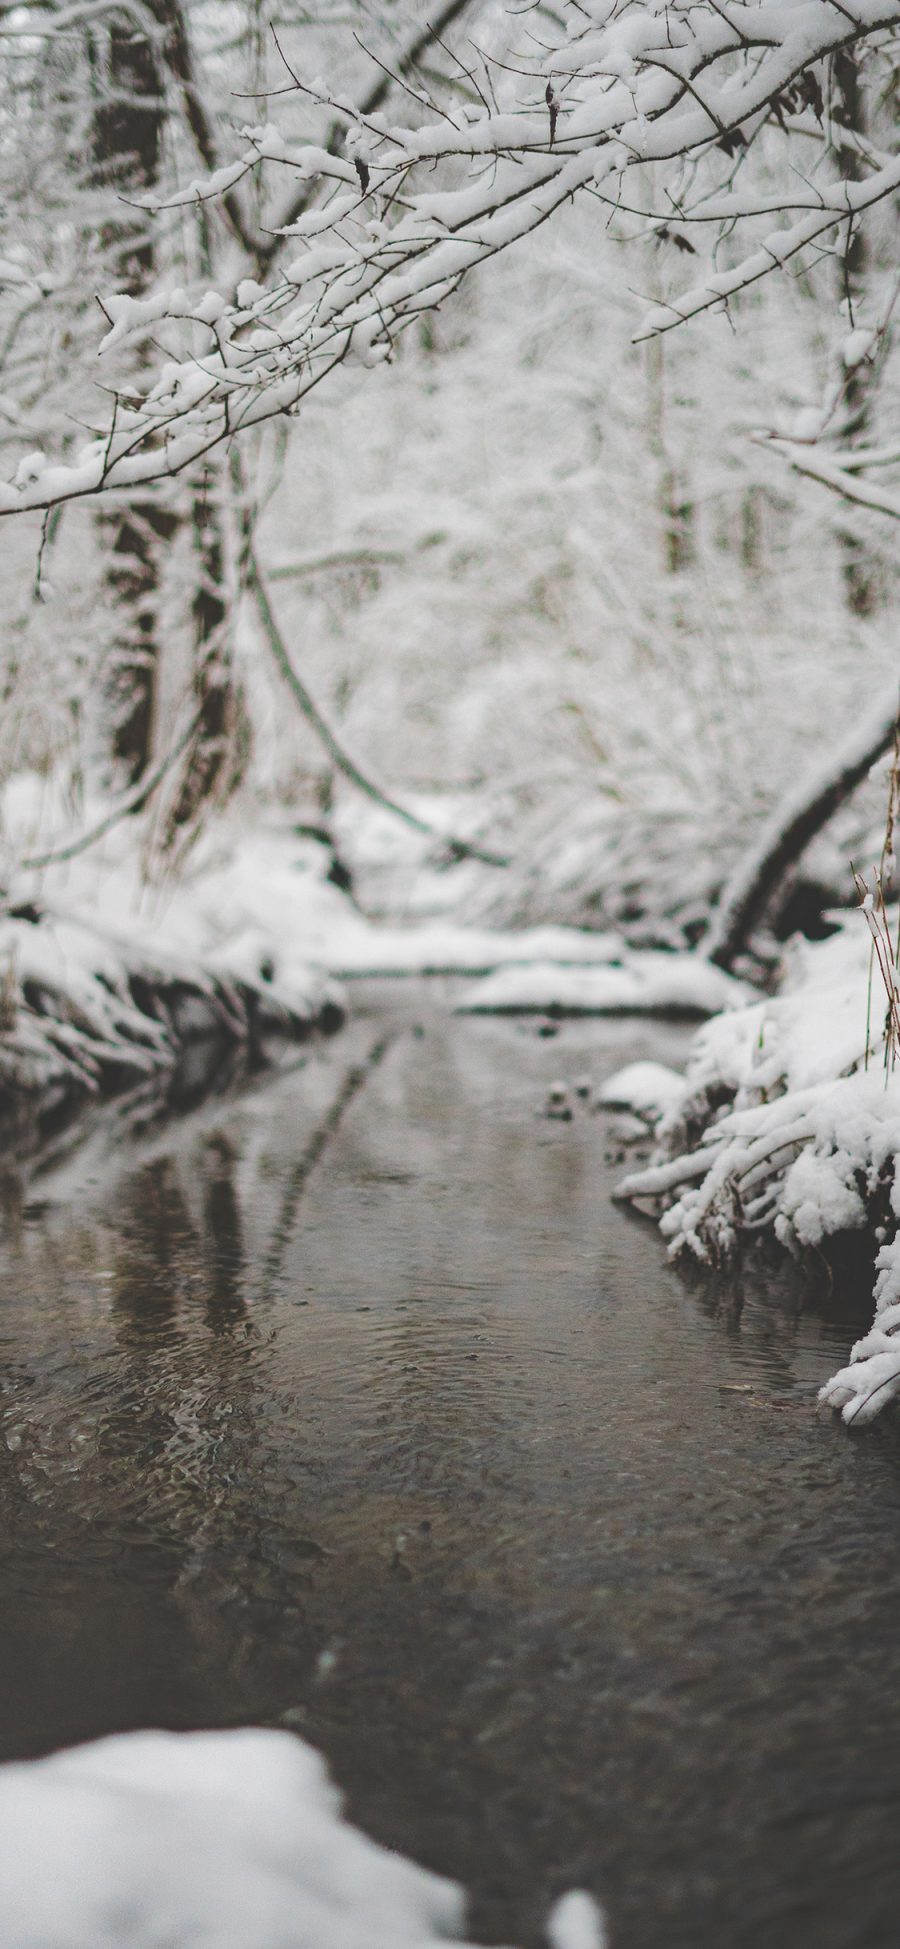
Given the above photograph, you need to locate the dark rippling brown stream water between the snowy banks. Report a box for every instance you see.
[0,988,900,1949]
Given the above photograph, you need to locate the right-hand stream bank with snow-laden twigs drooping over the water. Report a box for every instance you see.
[606,916,900,1423]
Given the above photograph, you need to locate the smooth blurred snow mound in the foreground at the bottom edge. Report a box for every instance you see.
[0,1729,604,1949]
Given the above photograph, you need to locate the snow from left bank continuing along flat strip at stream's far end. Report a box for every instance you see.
[0,774,744,1130]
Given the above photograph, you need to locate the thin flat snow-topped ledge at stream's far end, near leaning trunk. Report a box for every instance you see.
[460,947,752,1015]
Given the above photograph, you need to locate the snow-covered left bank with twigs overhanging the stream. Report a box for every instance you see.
[0,778,354,1134]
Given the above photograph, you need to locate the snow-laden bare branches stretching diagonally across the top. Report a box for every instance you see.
[0,0,900,513]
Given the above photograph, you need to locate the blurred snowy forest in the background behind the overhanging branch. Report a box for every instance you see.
[0,0,900,937]
